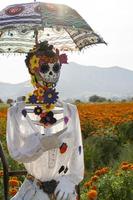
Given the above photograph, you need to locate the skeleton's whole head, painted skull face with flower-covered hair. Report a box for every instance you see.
[25,41,67,87]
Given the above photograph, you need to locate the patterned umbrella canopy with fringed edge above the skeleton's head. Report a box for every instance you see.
[0,2,105,53]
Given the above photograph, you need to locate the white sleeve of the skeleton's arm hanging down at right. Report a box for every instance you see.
[68,106,84,185]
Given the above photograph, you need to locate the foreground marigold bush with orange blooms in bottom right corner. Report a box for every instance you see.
[81,163,133,200]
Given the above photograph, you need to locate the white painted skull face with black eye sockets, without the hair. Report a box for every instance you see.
[38,62,61,83]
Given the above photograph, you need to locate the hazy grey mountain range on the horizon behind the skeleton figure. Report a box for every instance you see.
[0,62,133,100]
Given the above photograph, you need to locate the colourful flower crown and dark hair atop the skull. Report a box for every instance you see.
[25,41,67,75]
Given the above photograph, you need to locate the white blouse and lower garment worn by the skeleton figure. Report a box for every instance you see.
[7,103,84,200]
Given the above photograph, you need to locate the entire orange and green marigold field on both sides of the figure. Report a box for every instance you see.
[0,102,133,200]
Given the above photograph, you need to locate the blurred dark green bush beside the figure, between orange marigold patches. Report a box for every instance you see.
[84,135,122,170]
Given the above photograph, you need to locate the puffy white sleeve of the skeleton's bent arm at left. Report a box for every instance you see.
[6,106,43,163]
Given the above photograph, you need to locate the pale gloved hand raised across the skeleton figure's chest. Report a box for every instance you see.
[39,128,67,151]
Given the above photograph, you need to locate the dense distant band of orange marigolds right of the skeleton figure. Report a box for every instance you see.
[77,102,133,128]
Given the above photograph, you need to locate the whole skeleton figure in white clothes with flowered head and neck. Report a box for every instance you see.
[7,42,84,200]
